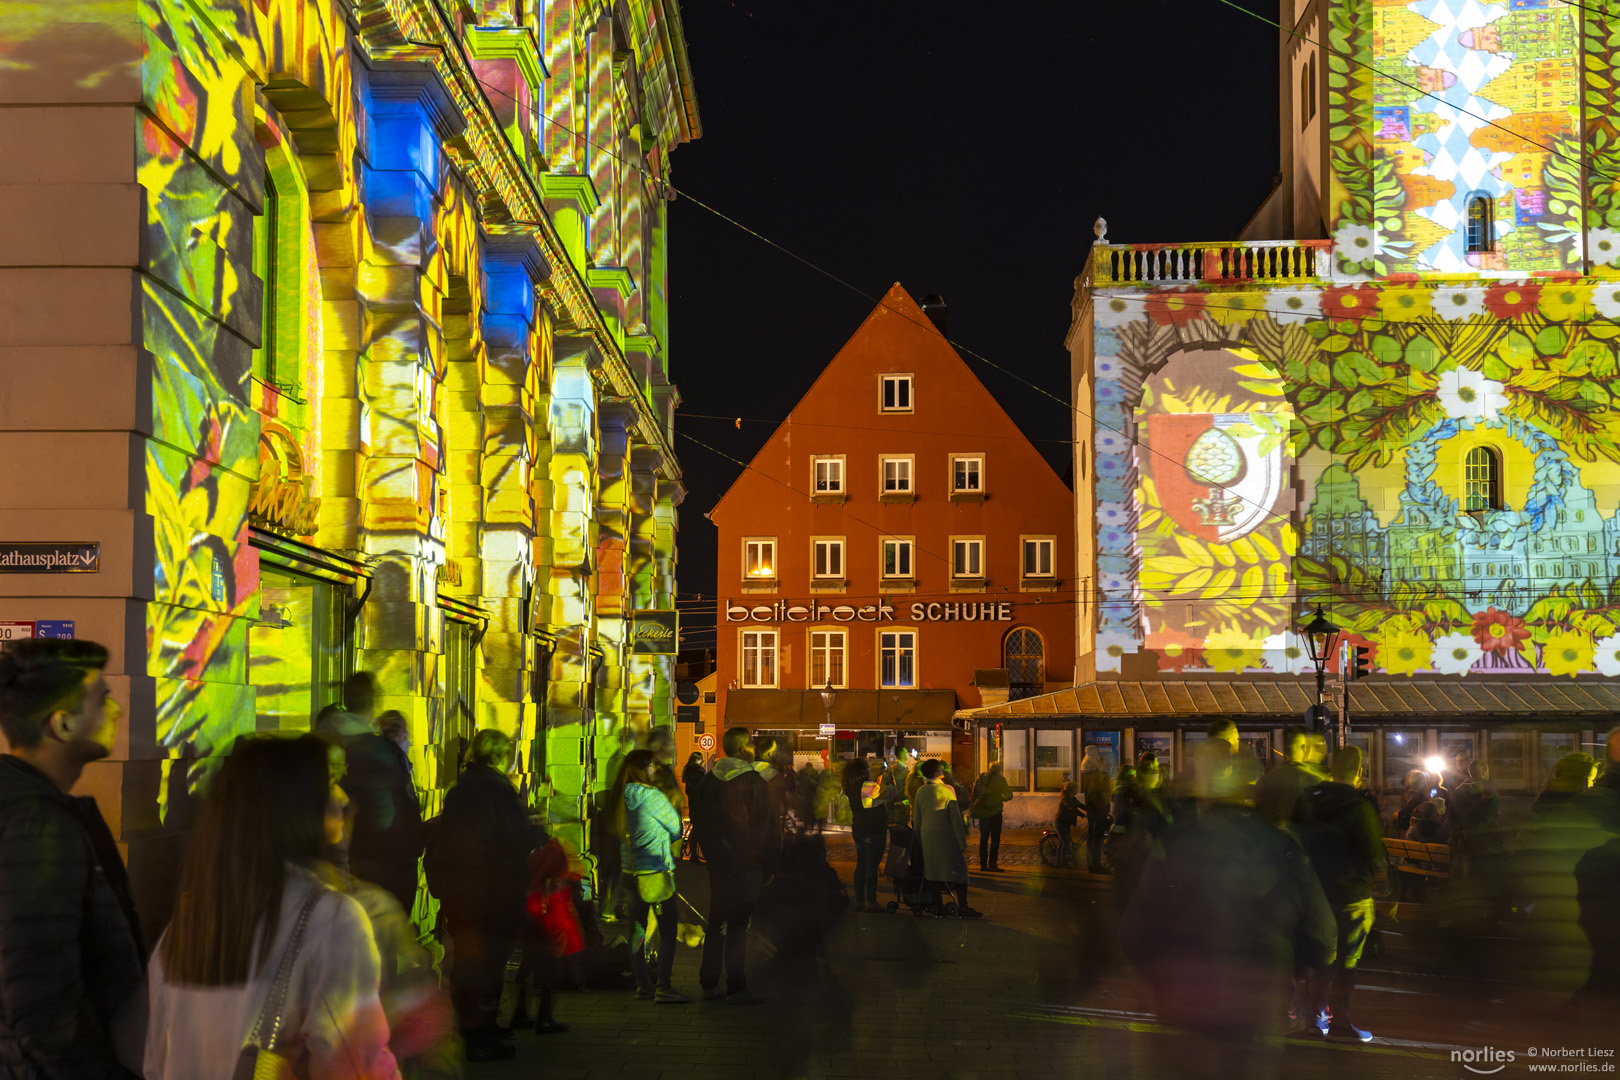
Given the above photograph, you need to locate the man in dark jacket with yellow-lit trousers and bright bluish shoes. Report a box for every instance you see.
[1298,746,1387,1043]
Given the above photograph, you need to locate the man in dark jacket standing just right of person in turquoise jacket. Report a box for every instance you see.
[692,727,773,1004]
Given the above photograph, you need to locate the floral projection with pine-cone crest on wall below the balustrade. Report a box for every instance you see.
[1095,280,1620,677]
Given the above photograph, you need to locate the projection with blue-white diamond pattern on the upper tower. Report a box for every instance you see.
[1327,0,1581,277]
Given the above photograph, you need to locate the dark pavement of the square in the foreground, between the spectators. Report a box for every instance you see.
[482,834,1620,1080]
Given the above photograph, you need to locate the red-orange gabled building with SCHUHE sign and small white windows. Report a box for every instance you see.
[710,285,1076,787]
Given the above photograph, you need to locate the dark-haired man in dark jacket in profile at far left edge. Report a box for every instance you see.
[0,638,146,1080]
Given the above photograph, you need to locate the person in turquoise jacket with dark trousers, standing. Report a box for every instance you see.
[620,750,692,1006]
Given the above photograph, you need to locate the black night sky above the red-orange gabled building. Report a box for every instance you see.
[669,0,1278,648]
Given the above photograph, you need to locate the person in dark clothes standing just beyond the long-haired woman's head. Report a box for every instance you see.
[316,672,426,912]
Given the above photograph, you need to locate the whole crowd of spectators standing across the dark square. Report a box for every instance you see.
[0,640,1620,1080]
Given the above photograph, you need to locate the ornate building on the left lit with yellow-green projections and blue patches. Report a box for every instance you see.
[0,0,700,916]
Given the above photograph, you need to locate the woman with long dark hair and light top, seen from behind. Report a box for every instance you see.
[146,735,399,1080]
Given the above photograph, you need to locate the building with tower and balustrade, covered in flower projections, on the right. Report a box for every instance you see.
[978,0,1620,790]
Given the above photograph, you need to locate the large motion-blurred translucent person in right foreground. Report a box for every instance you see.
[1119,738,1337,1078]
